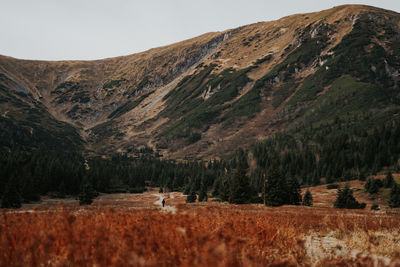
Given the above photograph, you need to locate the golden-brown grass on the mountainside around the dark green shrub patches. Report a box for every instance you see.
[0,5,399,159]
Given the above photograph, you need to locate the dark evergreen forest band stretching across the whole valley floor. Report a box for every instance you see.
[0,121,400,207]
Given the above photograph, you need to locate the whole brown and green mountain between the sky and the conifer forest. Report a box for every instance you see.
[0,5,400,159]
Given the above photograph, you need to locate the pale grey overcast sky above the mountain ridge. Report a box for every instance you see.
[0,0,400,60]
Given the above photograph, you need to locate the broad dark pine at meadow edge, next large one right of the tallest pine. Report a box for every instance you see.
[264,163,286,206]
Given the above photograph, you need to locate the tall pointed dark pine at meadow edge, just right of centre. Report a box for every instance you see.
[229,160,252,204]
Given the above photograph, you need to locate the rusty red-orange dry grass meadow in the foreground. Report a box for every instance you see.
[0,192,400,266]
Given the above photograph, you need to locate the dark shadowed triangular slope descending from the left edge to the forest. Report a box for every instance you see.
[0,73,83,152]
